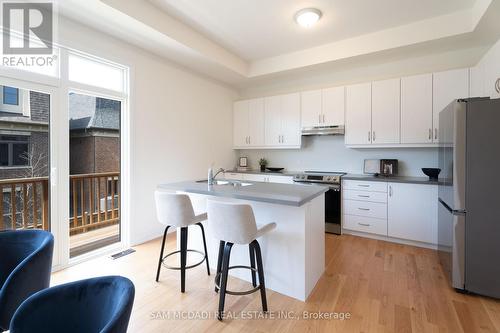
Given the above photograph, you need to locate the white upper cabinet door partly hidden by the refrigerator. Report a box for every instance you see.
[432,68,469,142]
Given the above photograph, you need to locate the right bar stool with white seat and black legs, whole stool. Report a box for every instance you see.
[207,200,276,320]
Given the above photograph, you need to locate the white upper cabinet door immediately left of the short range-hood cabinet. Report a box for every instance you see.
[281,93,301,146]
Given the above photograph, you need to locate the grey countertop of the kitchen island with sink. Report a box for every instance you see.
[158,181,328,207]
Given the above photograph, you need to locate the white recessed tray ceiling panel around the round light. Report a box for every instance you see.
[148,0,475,61]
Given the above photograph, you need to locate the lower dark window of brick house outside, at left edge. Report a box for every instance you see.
[0,135,29,167]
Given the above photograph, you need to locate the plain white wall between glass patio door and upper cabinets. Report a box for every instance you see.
[59,19,237,244]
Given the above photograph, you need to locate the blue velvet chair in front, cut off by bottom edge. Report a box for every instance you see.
[10,276,135,333]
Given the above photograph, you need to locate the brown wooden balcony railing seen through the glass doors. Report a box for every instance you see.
[0,172,120,235]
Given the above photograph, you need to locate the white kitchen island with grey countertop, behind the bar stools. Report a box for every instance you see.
[158,181,328,301]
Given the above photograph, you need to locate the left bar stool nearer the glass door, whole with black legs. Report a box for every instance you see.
[155,190,210,292]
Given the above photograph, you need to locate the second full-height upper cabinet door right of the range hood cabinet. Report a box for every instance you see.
[372,79,401,144]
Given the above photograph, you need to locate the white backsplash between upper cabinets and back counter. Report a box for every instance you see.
[239,136,438,177]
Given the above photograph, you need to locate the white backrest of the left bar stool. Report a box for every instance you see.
[155,190,195,227]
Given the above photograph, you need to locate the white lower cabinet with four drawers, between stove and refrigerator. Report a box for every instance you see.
[342,180,438,245]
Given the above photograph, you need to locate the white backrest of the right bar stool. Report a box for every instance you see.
[207,200,257,244]
